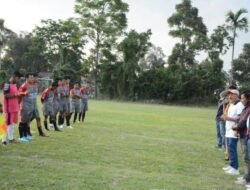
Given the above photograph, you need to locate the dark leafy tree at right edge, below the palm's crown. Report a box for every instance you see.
[233,43,250,89]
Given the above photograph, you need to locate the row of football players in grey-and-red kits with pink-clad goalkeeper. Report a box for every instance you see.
[2,71,90,145]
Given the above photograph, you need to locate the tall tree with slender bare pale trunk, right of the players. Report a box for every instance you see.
[75,0,128,97]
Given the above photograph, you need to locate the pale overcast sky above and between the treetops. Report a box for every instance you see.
[0,0,250,70]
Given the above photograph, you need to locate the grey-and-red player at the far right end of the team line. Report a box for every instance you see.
[79,84,90,122]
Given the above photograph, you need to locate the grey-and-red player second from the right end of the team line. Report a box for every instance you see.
[70,82,81,123]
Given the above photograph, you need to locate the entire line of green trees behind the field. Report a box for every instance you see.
[0,0,250,102]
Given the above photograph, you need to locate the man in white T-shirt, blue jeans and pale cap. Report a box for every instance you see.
[222,89,244,175]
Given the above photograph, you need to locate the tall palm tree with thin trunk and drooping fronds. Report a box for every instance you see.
[226,9,248,70]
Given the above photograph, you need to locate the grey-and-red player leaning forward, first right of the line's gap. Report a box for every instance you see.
[41,81,60,131]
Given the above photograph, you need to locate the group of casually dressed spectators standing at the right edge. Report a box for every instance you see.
[216,86,250,190]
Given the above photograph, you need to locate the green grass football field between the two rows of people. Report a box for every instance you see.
[0,101,245,190]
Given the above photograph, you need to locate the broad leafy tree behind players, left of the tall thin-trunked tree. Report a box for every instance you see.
[34,18,86,80]
